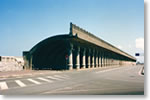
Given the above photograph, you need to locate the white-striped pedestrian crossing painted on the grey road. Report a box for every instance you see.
[0,75,70,91]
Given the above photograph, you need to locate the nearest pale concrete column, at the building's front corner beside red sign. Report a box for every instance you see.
[67,45,73,70]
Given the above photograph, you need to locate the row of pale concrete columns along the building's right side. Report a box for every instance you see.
[67,45,124,70]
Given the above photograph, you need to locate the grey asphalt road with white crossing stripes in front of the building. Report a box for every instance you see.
[0,66,144,95]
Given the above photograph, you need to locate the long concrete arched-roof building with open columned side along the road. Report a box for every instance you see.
[23,23,136,70]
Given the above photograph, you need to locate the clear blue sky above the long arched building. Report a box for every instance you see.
[0,0,144,62]
